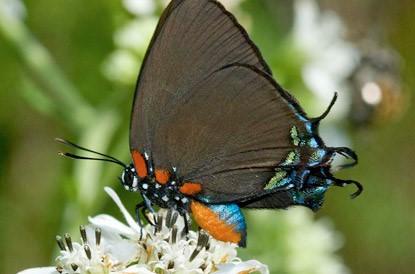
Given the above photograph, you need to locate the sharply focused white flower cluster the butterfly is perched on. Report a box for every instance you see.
[18,188,269,274]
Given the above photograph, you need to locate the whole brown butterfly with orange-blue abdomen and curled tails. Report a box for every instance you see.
[57,0,363,246]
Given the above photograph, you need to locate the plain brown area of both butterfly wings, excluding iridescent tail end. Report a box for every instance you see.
[130,0,332,204]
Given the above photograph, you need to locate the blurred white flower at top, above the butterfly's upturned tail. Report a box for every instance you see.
[293,0,360,119]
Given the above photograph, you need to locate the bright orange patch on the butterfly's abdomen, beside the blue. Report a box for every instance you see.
[190,201,242,244]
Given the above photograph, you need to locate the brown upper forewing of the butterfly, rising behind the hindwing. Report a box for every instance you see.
[130,0,271,154]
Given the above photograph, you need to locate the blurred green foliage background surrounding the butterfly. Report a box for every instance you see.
[0,0,415,274]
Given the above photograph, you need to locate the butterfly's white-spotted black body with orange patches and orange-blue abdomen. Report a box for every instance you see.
[120,152,250,246]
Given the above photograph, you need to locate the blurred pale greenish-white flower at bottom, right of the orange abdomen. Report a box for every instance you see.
[251,207,350,274]
